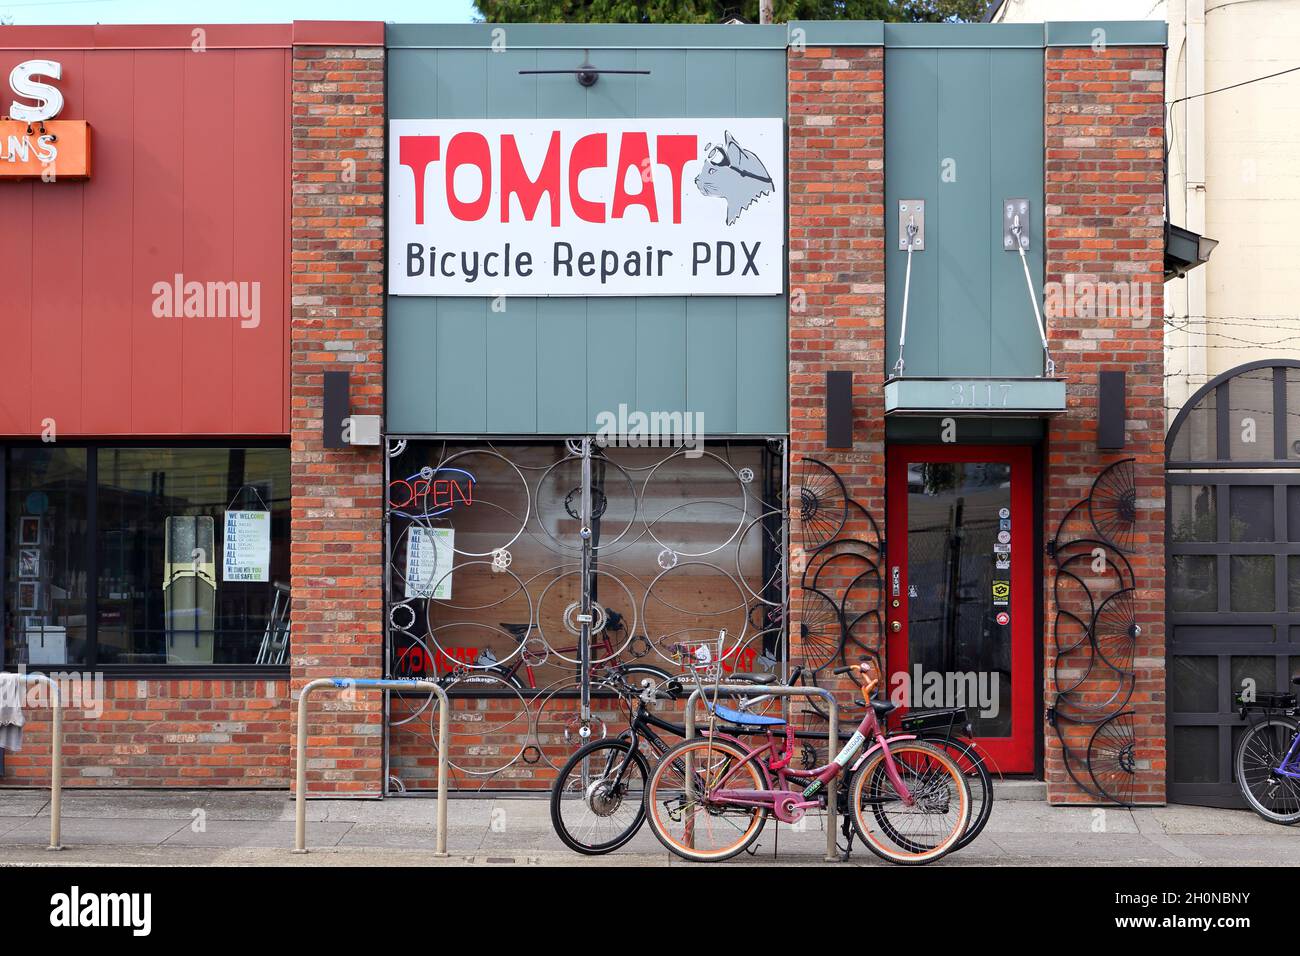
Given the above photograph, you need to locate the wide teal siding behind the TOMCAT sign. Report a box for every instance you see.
[386,41,788,434]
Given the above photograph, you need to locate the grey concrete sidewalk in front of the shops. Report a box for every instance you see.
[0,790,1300,866]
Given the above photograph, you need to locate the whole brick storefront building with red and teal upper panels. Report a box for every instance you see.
[0,22,1268,803]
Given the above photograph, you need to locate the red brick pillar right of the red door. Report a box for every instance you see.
[1044,47,1165,803]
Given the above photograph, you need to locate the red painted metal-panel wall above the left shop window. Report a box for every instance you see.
[0,48,290,437]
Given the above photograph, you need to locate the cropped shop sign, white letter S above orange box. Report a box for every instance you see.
[0,60,90,182]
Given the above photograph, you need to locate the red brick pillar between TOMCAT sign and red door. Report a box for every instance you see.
[788,47,885,659]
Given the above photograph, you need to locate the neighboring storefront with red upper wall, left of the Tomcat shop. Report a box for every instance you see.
[0,23,382,787]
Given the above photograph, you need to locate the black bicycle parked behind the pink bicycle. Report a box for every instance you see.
[551,666,993,858]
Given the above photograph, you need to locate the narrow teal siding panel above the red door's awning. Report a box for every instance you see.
[885,44,1043,377]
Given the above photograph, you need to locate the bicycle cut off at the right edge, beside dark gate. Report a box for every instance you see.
[1234,676,1300,826]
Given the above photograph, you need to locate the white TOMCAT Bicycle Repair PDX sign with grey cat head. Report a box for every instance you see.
[389,118,785,297]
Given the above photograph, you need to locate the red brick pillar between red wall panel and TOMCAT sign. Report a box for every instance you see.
[290,23,384,793]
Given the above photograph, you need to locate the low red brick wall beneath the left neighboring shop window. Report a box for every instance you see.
[4,680,291,787]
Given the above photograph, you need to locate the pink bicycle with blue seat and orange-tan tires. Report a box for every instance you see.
[645,648,971,865]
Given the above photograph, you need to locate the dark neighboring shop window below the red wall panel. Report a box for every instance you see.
[4,447,290,667]
